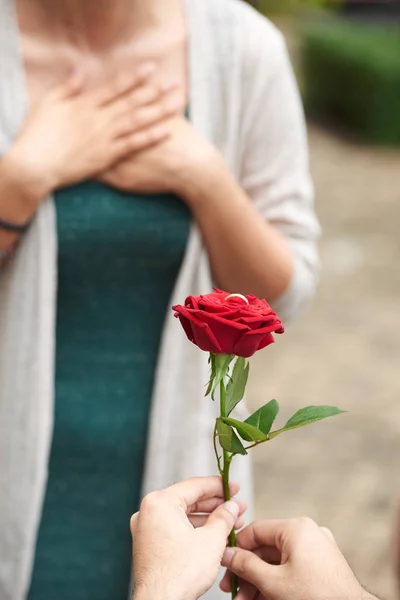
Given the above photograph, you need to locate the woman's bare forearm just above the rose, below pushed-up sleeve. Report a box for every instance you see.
[181,157,294,301]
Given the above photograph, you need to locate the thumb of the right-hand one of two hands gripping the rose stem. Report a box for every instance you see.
[222,548,276,596]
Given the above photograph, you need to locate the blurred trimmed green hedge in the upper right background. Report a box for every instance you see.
[302,19,400,144]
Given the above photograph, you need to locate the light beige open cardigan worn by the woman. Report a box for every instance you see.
[0,0,319,600]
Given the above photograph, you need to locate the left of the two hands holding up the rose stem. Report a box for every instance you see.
[131,477,246,600]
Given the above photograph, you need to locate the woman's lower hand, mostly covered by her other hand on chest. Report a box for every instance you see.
[99,116,222,201]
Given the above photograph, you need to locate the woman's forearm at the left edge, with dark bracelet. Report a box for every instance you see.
[0,153,46,268]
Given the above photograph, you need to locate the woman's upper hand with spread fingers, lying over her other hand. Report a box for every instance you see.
[8,64,182,202]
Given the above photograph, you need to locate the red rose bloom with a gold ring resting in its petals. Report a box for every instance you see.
[173,289,284,358]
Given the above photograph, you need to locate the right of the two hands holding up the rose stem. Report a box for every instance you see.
[221,519,376,600]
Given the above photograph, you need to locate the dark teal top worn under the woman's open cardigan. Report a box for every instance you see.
[28,182,190,600]
